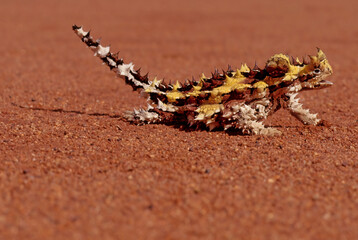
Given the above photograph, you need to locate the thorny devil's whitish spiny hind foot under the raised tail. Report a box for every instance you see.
[124,105,161,125]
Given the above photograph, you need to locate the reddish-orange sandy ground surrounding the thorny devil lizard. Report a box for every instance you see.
[0,0,358,239]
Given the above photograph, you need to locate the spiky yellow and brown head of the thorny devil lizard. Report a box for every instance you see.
[298,48,333,90]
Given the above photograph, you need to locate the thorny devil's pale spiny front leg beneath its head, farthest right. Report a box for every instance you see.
[285,93,321,125]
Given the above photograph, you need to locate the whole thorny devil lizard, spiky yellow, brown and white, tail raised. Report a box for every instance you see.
[72,25,333,134]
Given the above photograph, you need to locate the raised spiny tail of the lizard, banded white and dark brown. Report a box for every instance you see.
[72,25,167,94]
